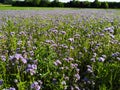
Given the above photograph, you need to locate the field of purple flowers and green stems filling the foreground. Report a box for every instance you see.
[0,9,120,90]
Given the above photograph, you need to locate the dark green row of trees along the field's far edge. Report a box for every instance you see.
[0,0,120,8]
